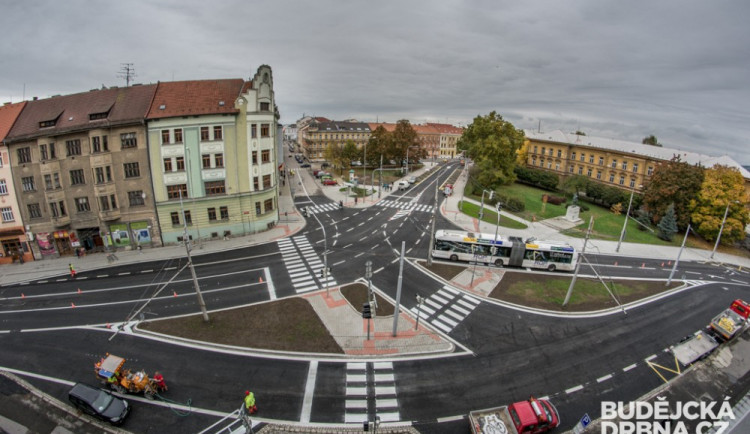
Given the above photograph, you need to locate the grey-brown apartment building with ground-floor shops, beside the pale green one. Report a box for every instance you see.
[4,85,161,258]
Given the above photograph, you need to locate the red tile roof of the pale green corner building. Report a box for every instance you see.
[146,78,245,119]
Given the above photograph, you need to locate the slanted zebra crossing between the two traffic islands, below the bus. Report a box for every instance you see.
[410,285,480,333]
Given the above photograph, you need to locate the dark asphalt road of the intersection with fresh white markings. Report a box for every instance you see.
[0,161,748,433]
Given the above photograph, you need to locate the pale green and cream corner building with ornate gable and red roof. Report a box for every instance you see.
[146,65,279,244]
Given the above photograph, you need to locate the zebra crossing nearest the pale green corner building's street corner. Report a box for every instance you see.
[276,235,337,294]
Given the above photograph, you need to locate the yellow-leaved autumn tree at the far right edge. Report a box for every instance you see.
[690,164,750,244]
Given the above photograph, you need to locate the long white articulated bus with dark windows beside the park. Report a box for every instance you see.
[432,230,578,271]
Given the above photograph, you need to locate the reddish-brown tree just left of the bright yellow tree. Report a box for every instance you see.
[643,157,704,230]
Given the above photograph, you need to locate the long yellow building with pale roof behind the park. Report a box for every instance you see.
[524,130,750,192]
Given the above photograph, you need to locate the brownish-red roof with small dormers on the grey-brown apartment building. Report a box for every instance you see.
[7,84,156,140]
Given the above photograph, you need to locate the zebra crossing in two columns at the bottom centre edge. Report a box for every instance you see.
[344,362,401,423]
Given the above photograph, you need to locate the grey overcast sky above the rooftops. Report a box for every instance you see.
[0,0,750,164]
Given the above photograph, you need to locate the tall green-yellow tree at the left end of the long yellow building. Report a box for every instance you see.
[456,111,524,188]
